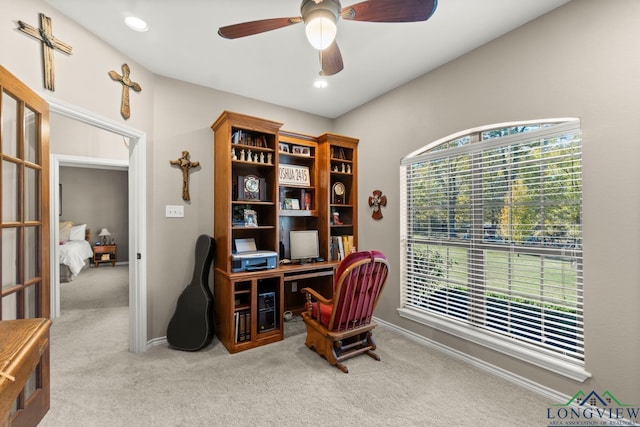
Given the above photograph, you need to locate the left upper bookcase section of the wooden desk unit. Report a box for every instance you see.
[212,111,282,272]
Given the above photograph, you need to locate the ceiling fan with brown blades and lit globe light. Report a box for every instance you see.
[218,0,438,76]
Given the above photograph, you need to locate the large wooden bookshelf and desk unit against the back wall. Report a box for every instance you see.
[211,111,358,353]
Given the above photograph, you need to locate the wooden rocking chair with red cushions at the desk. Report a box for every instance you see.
[302,251,389,373]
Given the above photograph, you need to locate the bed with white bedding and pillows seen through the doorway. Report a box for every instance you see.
[58,221,93,282]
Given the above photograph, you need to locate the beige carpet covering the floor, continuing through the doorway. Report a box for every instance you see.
[41,267,554,426]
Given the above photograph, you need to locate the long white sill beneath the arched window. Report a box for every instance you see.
[398,308,591,382]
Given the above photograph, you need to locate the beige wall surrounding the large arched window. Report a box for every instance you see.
[335,0,640,402]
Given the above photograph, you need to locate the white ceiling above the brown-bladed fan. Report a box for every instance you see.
[46,0,569,118]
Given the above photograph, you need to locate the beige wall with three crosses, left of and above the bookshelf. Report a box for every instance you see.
[0,0,332,340]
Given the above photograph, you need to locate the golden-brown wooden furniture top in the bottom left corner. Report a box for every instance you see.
[0,319,51,426]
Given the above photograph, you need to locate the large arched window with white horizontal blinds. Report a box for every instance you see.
[399,119,589,380]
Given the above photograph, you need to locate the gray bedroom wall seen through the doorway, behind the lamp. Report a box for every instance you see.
[60,167,129,262]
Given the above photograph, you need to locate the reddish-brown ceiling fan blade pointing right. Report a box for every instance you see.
[340,0,438,22]
